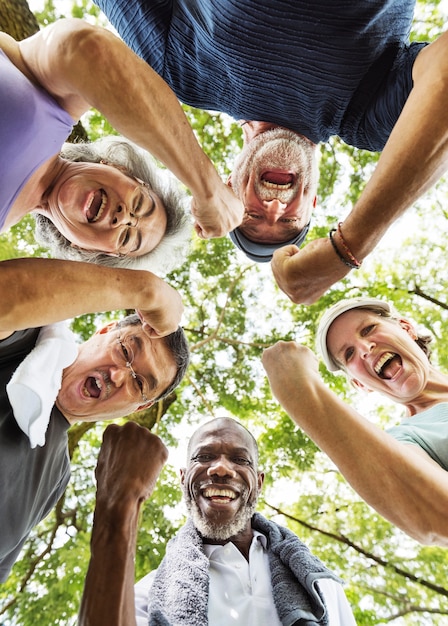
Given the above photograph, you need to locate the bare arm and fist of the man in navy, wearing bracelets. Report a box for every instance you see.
[272,33,448,304]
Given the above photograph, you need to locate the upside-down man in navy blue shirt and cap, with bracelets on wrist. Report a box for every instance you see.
[96,0,448,303]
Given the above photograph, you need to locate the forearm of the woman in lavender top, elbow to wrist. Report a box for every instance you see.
[86,33,222,197]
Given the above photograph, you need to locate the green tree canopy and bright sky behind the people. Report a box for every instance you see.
[0,0,448,626]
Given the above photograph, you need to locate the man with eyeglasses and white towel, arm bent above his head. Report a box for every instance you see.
[0,259,189,582]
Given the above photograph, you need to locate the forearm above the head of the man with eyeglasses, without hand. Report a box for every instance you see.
[0,258,160,332]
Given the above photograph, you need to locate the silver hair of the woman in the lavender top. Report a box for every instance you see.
[33,136,192,274]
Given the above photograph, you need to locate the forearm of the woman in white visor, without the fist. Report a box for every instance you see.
[277,382,448,546]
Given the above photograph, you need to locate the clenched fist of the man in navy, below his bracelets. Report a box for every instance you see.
[271,237,350,304]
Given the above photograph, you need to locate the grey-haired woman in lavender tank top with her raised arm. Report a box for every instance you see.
[0,19,243,269]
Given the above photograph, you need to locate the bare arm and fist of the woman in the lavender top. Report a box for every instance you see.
[20,19,243,238]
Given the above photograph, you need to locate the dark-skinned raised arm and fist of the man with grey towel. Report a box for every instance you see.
[78,422,168,626]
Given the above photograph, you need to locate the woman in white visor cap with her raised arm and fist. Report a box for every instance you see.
[263,298,448,546]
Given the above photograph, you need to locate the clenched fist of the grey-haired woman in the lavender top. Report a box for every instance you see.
[191,181,244,239]
